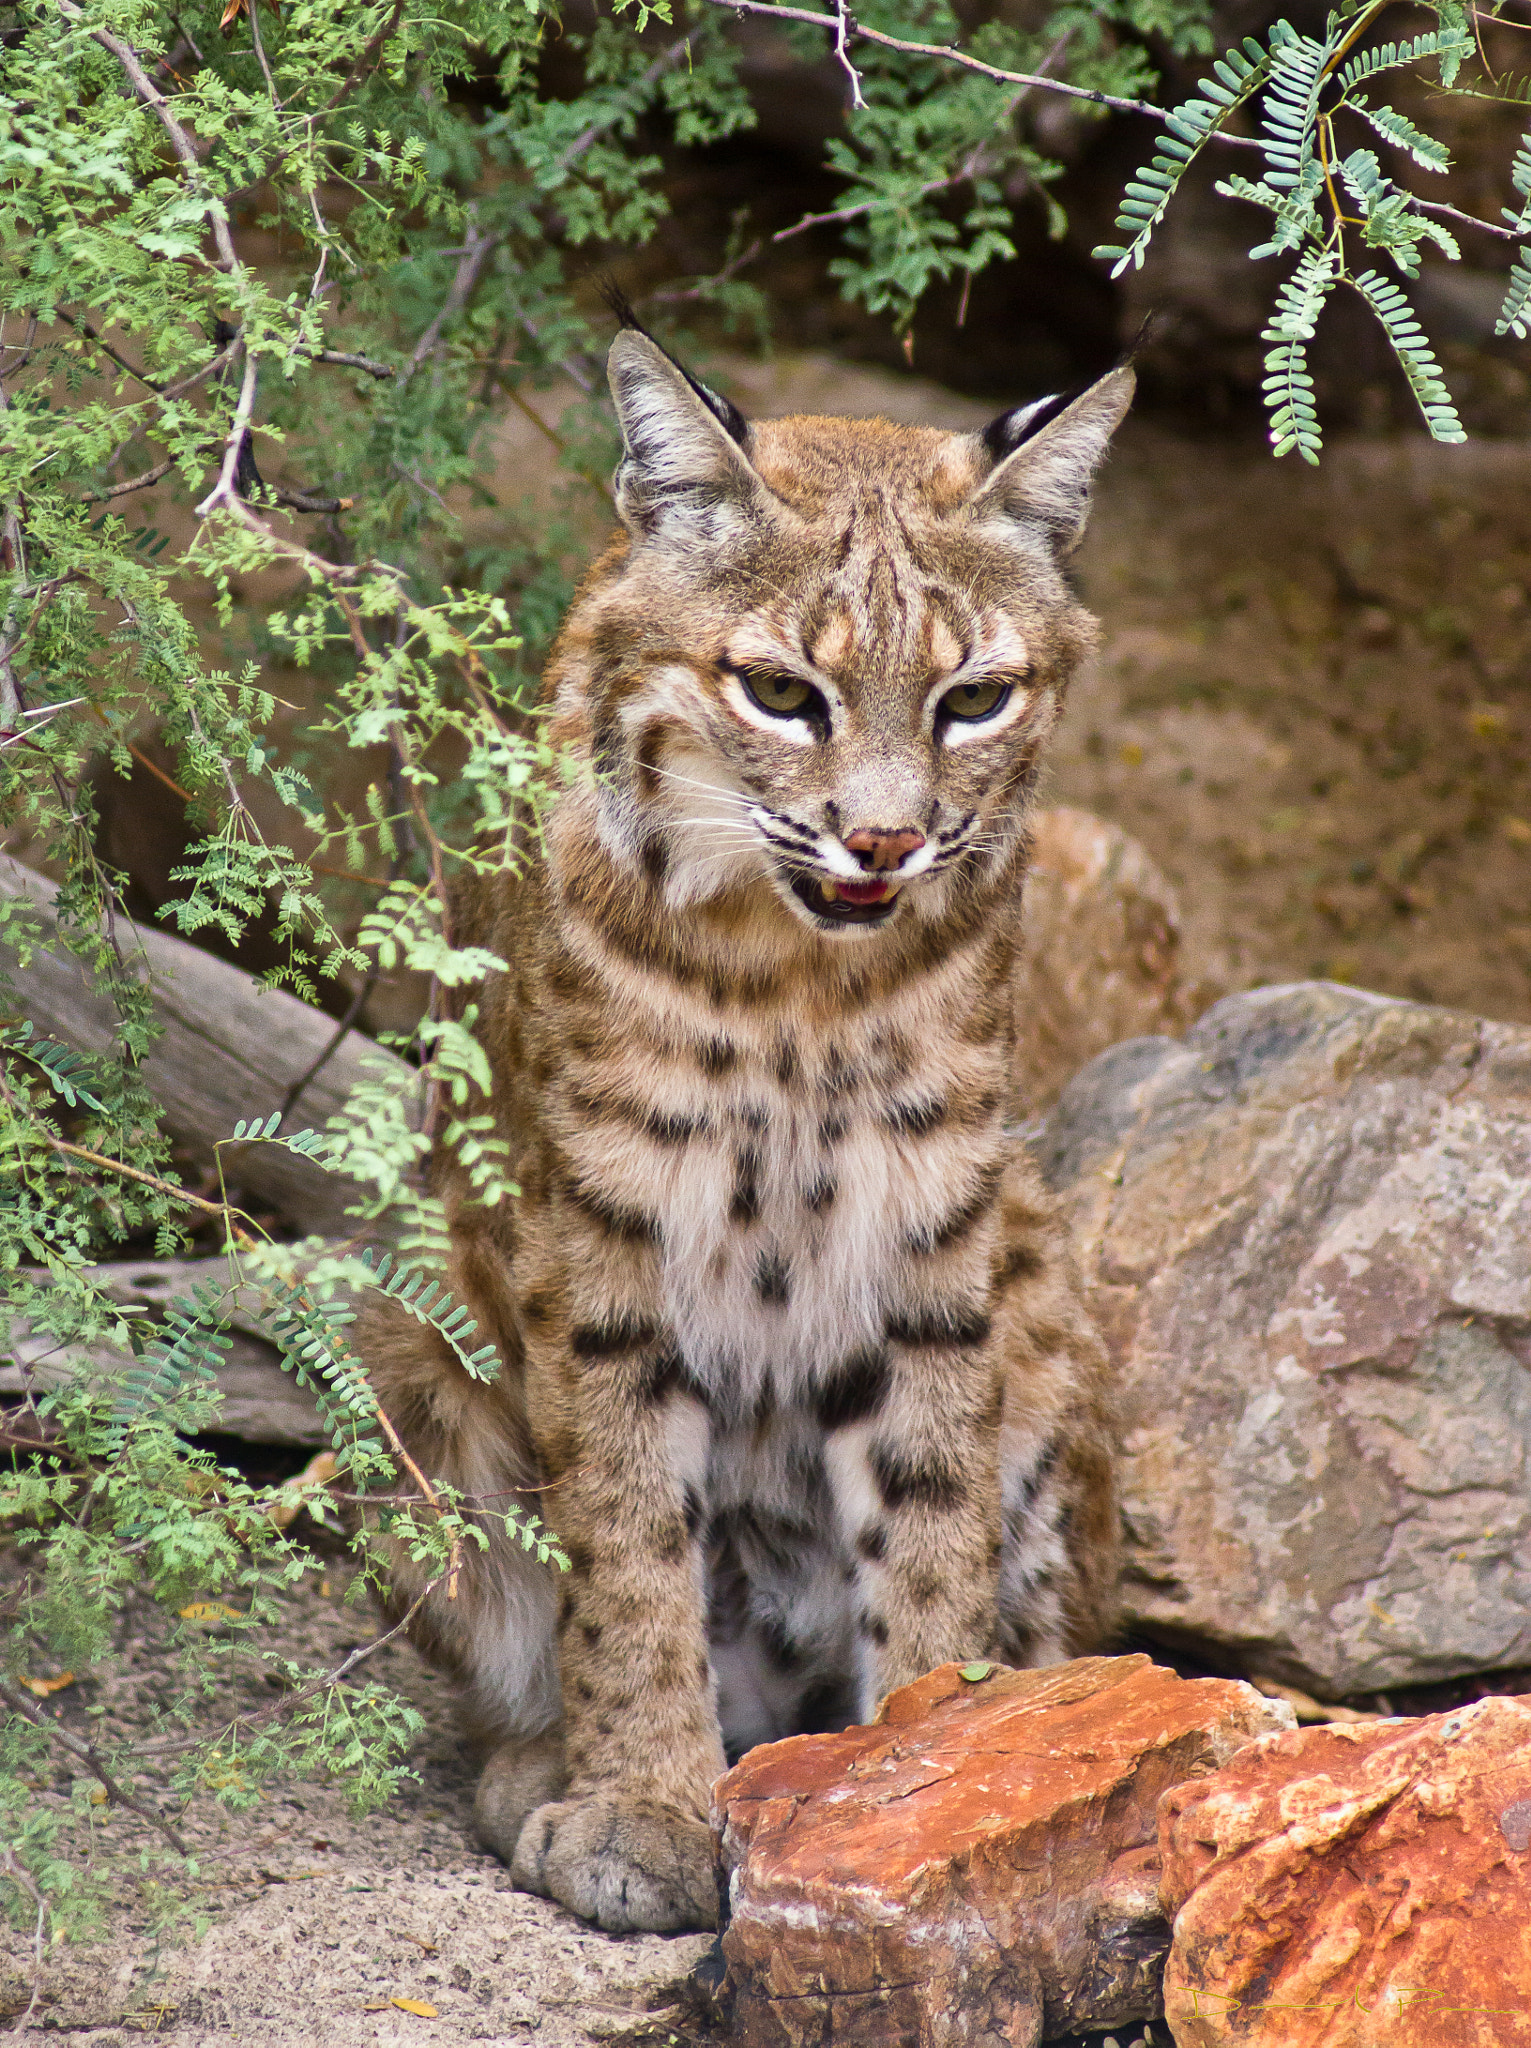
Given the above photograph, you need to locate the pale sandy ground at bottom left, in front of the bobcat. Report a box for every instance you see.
[0,1579,708,2048]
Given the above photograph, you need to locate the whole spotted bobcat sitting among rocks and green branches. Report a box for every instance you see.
[364,328,1132,1931]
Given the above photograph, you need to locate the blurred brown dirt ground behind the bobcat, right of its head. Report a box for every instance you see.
[1052,428,1531,1020]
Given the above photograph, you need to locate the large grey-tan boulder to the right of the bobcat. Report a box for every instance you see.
[1025,983,1531,1698]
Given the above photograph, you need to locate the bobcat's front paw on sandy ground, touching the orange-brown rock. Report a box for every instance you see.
[510,1798,718,1933]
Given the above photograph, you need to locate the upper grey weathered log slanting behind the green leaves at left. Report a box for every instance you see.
[0,854,407,1235]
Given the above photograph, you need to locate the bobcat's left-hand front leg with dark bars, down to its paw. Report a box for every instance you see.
[512,1282,725,1933]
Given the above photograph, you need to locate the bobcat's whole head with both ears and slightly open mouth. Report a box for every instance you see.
[544,332,1132,938]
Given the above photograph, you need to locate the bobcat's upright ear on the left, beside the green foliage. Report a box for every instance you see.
[606,328,768,545]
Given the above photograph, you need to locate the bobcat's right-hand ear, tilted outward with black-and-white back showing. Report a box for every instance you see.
[972,369,1136,553]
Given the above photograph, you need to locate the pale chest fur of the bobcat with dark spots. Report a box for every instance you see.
[556,991,1001,1419]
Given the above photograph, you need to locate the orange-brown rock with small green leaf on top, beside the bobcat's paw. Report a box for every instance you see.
[712,1657,1289,2048]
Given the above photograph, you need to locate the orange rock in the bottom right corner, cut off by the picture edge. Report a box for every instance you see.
[1158,1700,1531,2048]
